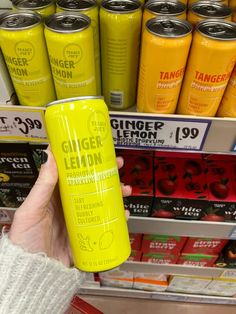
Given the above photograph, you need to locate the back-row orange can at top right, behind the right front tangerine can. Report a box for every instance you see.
[187,1,232,26]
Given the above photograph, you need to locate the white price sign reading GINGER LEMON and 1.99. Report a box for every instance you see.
[110,113,211,151]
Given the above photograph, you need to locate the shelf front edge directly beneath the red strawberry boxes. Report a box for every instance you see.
[120,262,225,278]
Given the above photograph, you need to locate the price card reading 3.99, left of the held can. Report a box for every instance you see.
[0,106,47,142]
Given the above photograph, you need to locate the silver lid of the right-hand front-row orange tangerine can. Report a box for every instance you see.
[196,19,236,41]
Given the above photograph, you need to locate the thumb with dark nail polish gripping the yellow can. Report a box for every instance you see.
[17,148,58,213]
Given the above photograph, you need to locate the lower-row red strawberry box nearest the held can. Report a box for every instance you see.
[142,252,179,265]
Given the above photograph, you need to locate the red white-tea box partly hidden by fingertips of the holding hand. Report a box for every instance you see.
[116,150,154,217]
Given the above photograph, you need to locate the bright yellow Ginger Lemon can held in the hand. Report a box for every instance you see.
[45,97,130,272]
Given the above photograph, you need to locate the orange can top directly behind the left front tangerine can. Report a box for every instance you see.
[142,0,186,29]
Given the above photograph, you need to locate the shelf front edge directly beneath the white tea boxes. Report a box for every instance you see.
[128,216,236,239]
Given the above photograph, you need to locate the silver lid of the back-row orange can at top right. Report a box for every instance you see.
[190,1,232,18]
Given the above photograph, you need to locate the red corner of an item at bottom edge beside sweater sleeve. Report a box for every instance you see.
[65,296,104,314]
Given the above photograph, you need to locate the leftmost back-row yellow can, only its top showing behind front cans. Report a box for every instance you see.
[12,0,56,18]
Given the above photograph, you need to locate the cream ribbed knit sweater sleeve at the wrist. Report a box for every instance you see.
[0,235,83,314]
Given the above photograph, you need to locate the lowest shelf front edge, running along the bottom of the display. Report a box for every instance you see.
[79,287,236,305]
